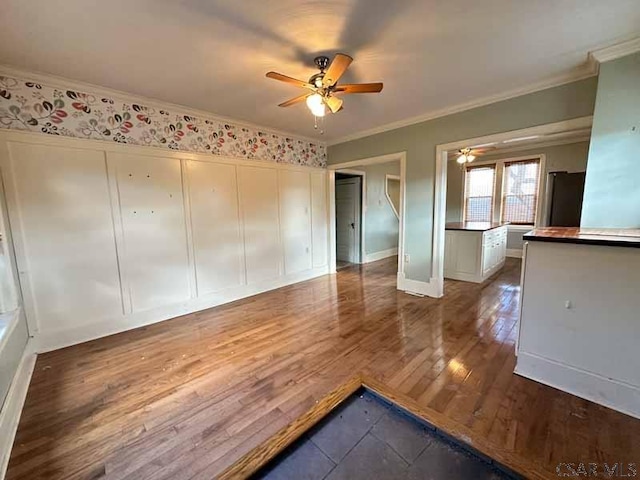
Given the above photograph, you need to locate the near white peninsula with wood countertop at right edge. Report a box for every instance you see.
[516,227,640,418]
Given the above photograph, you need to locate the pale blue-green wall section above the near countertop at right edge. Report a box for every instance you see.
[581,53,640,228]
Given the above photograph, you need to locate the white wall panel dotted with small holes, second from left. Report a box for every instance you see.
[107,153,191,312]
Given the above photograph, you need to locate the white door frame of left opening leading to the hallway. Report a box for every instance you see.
[327,152,407,279]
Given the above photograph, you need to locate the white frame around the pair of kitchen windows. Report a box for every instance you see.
[462,153,547,231]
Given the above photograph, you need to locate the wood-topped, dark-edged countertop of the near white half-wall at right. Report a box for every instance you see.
[522,227,640,248]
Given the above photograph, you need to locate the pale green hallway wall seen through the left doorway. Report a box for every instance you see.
[358,161,400,255]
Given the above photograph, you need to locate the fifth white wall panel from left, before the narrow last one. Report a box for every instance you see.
[279,170,312,275]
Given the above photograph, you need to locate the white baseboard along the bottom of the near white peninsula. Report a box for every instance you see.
[515,351,640,419]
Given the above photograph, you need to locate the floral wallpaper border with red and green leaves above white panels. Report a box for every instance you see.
[0,74,327,167]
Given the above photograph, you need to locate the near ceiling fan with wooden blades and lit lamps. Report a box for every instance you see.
[267,53,382,117]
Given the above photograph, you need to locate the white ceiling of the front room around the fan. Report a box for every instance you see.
[0,0,640,141]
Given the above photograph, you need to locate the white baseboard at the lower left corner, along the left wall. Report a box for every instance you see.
[0,339,36,480]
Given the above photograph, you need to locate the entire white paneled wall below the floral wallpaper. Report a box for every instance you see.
[0,132,328,351]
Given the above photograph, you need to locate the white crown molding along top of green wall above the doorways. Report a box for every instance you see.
[327,62,598,146]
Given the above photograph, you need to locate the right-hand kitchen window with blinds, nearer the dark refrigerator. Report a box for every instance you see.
[502,159,540,225]
